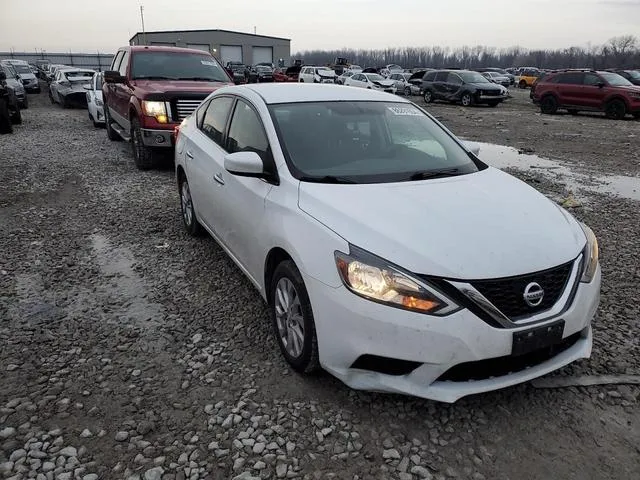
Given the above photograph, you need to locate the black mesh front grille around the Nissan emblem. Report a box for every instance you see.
[471,262,573,320]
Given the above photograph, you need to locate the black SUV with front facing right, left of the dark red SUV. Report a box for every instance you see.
[422,70,509,107]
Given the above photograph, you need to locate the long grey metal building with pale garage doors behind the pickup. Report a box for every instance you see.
[129,30,291,65]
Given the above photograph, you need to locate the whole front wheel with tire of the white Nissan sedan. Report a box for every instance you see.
[269,260,320,373]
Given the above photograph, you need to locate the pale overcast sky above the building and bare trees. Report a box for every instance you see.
[0,0,640,52]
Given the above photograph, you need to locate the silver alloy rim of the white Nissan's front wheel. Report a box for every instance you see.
[275,277,305,358]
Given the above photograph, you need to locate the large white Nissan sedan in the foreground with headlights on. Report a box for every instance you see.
[175,84,601,402]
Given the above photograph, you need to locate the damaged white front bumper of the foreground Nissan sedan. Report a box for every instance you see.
[304,268,601,402]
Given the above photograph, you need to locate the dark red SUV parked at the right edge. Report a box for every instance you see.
[532,70,640,119]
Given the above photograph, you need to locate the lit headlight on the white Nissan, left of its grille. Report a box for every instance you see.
[335,246,460,316]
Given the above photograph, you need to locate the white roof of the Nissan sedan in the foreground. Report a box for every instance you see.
[218,83,410,104]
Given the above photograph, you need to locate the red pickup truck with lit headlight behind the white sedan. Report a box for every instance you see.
[102,46,233,170]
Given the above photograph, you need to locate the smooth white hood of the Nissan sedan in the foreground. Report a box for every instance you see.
[298,167,585,280]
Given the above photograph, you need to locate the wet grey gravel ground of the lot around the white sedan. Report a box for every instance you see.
[0,84,640,480]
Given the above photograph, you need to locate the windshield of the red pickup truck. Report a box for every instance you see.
[131,51,233,82]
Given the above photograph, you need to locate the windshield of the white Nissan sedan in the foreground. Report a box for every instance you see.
[270,102,479,183]
